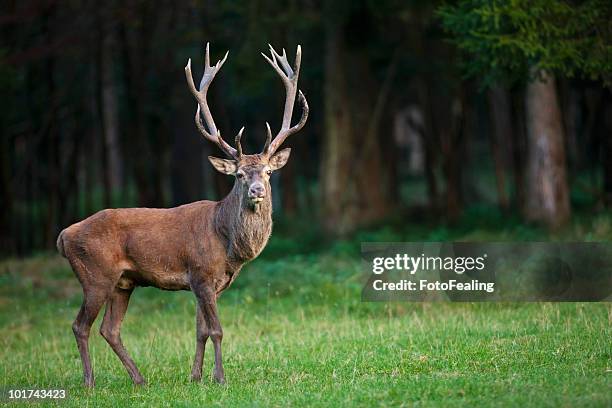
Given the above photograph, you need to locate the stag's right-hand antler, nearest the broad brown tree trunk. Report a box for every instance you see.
[261,44,308,157]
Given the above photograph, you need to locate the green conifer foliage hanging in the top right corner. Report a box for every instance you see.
[438,0,612,84]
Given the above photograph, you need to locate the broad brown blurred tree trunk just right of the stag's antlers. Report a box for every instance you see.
[321,21,392,235]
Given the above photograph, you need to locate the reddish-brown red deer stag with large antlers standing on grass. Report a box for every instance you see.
[57,44,308,387]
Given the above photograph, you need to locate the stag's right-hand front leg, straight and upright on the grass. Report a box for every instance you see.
[192,284,225,384]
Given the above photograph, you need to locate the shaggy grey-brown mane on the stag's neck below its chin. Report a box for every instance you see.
[215,181,272,264]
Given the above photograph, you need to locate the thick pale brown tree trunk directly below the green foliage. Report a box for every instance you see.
[525,73,570,227]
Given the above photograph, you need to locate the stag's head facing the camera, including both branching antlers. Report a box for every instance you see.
[185,43,308,205]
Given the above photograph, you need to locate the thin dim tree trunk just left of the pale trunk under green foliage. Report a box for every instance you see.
[489,85,514,211]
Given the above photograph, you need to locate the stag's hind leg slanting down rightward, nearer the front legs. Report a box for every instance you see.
[100,287,145,385]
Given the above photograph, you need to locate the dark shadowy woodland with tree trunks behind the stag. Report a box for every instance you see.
[0,0,612,255]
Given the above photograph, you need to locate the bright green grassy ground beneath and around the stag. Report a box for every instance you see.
[0,209,612,407]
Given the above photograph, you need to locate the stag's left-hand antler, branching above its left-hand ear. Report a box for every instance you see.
[185,43,244,159]
